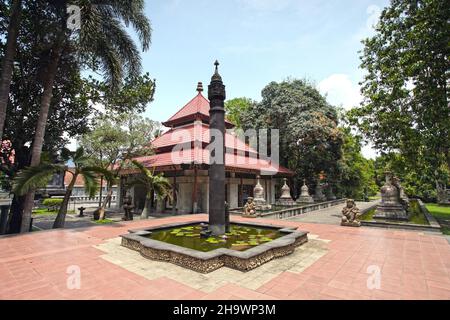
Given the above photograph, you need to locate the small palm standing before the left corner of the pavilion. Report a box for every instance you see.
[127,160,172,219]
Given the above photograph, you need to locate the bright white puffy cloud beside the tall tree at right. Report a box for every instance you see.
[318,73,362,109]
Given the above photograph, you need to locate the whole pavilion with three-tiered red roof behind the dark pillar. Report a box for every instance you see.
[117,82,294,214]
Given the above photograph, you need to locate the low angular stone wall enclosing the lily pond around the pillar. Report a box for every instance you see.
[121,221,308,273]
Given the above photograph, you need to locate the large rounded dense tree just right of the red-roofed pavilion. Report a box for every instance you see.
[241,79,342,193]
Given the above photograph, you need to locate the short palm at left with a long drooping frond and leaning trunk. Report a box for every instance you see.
[13,148,111,228]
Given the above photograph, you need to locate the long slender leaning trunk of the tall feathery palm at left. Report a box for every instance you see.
[20,38,62,233]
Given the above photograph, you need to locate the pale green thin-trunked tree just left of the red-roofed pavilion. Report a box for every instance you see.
[80,113,159,219]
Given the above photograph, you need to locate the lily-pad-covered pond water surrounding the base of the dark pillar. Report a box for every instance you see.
[145,224,285,252]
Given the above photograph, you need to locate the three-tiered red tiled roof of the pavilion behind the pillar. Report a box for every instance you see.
[132,83,293,176]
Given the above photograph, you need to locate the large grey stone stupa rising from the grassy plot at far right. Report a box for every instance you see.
[374,172,409,220]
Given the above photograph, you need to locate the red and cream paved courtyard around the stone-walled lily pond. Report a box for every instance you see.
[0,215,450,300]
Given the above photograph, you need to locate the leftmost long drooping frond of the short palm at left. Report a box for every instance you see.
[13,163,65,195]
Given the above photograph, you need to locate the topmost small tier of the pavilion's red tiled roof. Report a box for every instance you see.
[163,92,234,127]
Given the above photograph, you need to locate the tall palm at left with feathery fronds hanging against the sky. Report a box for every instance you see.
[20,0,151,232]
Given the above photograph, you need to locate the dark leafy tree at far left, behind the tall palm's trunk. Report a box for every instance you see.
[0,2,92,233]
